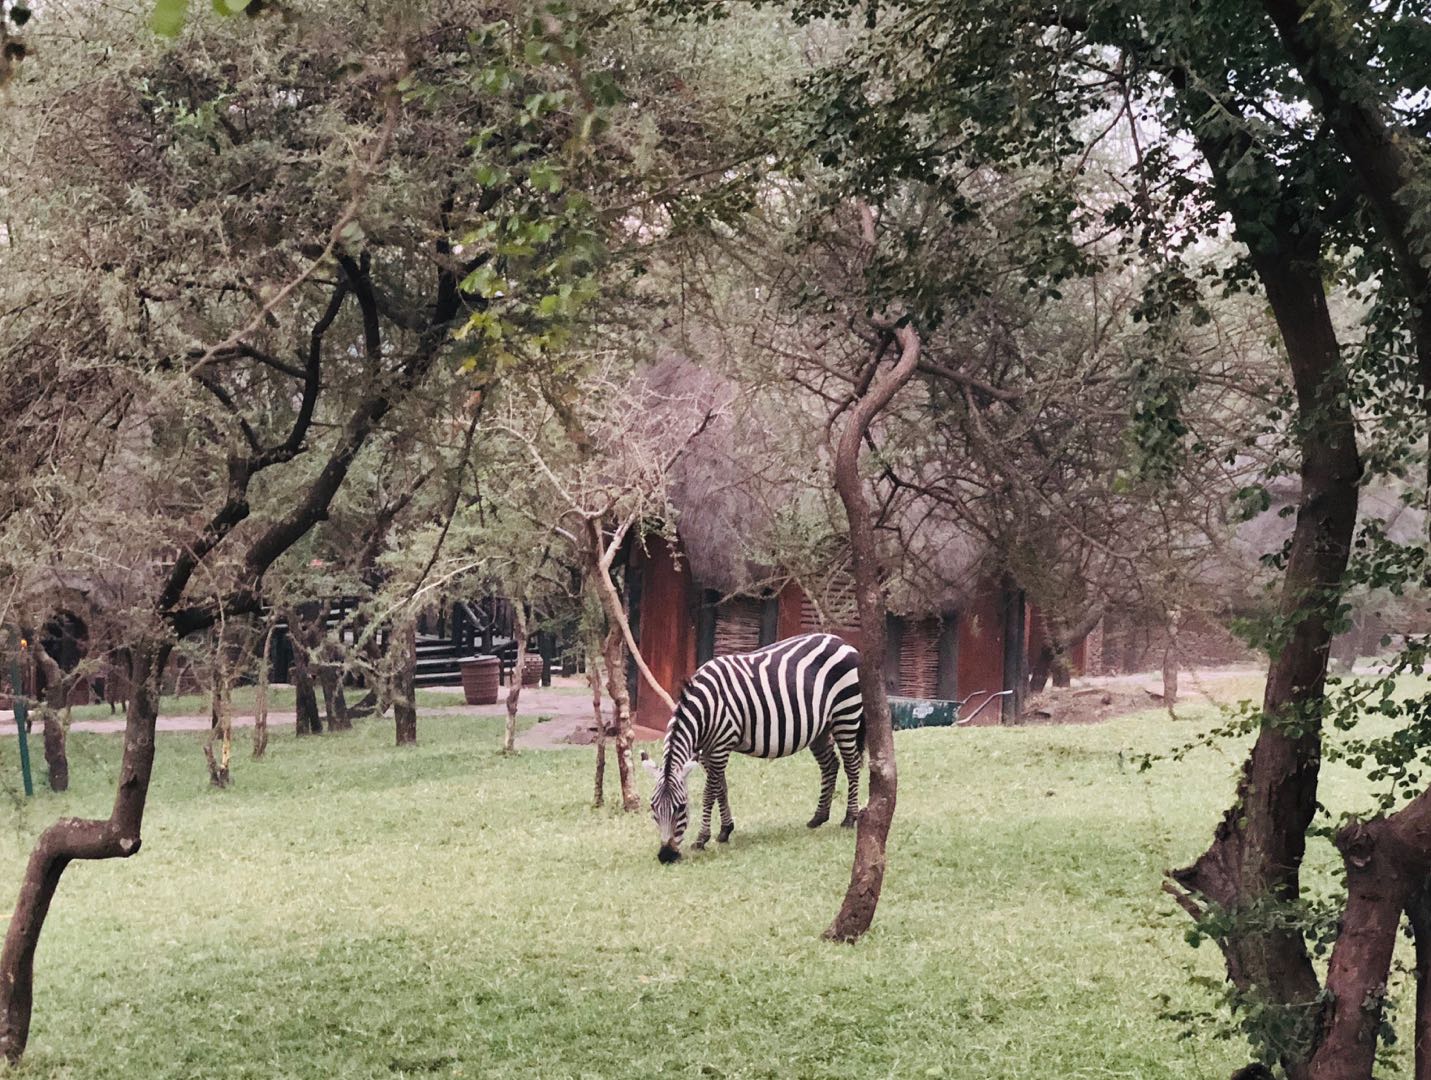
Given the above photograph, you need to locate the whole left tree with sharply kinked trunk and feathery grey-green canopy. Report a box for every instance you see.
[0,3,626,1061]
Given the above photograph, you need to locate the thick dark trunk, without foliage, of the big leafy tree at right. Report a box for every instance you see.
[1173,236,1361,1080]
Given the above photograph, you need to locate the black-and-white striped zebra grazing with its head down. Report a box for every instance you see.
[641,634,864,863]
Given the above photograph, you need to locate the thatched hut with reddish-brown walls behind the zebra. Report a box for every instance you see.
[625,359,1027,730]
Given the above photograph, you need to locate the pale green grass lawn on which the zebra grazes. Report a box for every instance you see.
[0,714,1396,1080]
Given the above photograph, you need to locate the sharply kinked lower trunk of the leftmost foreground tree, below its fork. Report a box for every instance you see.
[0,641,170,1063]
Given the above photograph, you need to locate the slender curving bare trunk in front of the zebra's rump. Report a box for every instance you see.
[824,326,920,941]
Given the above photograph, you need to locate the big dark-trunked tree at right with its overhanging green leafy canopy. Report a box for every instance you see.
[652,1,1425,1077]
